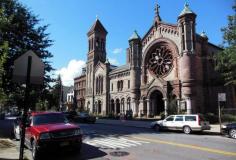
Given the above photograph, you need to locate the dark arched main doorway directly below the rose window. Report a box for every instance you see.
[150,90,165,116]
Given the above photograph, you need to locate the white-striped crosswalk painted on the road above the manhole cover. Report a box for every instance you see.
[84,137,149,149]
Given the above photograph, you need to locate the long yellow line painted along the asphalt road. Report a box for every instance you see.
[132,137,236,156]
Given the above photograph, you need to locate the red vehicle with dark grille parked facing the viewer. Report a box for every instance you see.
[25,112,82,160]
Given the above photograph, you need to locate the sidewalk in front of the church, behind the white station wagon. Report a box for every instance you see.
[96,119,220,135]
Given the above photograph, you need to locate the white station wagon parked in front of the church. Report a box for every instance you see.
[151,114,210,134]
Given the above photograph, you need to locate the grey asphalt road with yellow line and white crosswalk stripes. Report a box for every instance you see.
[0,120,236,160]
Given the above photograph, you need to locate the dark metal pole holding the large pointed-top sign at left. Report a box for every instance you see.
[19,56,32,160]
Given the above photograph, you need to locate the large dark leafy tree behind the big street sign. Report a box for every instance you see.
[0,0,53,109]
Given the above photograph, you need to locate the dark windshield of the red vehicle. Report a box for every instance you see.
[33,113,67,125]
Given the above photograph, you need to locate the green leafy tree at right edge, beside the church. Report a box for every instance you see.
[215,4,236,85]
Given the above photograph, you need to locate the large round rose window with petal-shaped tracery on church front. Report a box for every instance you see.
[147,46,173,77]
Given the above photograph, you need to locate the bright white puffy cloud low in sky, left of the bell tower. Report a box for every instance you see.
[55,59,85,86]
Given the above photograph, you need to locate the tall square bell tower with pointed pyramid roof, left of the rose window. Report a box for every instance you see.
[86,19,107,112]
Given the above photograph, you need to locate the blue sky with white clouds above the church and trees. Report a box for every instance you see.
[19,0,235,86]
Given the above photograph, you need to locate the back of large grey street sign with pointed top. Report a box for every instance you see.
[12,50,44,84]
